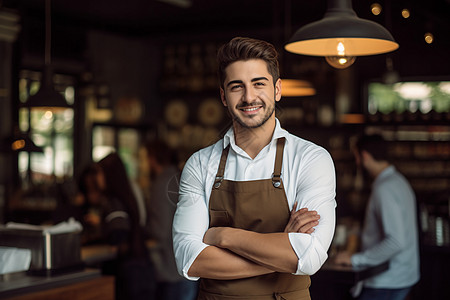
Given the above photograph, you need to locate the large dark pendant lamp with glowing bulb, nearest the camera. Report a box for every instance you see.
[285,0,399,69]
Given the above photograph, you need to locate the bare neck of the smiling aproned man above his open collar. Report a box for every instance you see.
[233,118,275,159]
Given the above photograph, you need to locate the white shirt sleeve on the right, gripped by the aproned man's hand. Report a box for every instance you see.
[289,148,336,275]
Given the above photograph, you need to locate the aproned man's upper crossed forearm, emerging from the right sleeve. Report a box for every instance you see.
[204,227,298,273]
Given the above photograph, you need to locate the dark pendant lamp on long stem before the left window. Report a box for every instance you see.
[23,0,70,110]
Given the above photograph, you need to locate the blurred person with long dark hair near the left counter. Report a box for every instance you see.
[79,153,156,300]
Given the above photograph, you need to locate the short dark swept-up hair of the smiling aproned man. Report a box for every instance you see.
[217,37,280,88]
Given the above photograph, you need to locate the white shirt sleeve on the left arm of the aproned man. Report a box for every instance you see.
[172,154,209,280]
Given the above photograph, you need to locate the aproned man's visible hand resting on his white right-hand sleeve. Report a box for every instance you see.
[284,202,320,234]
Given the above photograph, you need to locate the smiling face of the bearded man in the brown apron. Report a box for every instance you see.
[220,59,281,128]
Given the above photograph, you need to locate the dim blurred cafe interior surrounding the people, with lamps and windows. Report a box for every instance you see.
[0,0,450,299]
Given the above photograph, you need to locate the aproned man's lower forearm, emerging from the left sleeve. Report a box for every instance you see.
[188,246,273,280]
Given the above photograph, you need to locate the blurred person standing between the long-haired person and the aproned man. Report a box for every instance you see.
[145,140,197,300]
